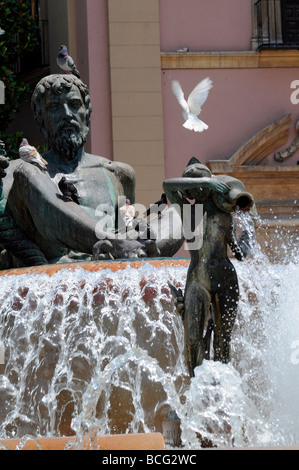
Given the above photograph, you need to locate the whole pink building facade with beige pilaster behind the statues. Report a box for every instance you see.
[10,0,299,255]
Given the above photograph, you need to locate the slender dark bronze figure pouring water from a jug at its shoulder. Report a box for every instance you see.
[163,158,254,376]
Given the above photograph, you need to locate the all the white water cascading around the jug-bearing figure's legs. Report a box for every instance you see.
[0,214,299,449]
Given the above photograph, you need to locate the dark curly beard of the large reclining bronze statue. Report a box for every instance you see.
[49,123,89,160]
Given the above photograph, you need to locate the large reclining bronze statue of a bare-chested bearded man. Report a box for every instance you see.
[0,74,182,265]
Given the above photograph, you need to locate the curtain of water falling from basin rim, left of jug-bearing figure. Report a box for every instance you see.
[0,265,186,437]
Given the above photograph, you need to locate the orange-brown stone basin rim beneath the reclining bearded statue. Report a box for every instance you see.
[0,257,190,276]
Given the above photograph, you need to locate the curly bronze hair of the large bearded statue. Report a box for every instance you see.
[31,74,92,135]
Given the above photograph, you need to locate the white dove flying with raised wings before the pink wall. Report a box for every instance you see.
[171,77,213,132]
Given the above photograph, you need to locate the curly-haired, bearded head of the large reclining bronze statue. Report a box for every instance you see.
[32,74,92,160]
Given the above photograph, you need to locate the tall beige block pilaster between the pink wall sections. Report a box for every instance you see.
[108,0,164,206]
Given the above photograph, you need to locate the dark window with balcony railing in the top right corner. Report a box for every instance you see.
[252,0,299,49]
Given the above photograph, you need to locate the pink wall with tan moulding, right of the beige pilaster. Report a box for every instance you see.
[160,0,299,176]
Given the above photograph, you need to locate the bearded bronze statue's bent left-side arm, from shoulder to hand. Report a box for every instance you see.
[8,162,150,258]
